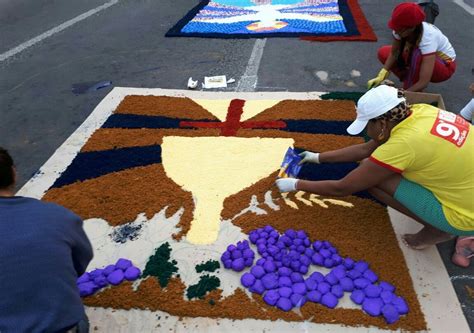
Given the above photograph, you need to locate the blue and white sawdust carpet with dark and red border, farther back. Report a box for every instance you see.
[166,0,377,41]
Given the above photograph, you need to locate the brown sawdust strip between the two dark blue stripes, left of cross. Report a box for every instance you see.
[81,128,220,152]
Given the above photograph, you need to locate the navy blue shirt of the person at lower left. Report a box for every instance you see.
[0,197,92,333]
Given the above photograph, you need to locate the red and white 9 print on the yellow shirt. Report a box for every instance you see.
[431,110,470,147]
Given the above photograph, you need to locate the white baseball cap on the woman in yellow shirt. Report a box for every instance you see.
[347,85,406,135]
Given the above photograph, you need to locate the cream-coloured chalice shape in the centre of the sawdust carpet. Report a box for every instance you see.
[161,136,294,245]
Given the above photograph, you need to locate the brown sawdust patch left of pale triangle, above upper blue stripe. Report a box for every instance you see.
[115,95,218,120]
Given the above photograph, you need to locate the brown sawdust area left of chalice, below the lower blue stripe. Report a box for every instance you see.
[43,164,194,238]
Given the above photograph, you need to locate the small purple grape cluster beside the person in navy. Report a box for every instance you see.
[76,258,141,297]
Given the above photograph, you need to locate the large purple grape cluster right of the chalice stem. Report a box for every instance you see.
[221,225,408,324]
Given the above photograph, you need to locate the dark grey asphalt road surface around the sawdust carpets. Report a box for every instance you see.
[0,0,474,330]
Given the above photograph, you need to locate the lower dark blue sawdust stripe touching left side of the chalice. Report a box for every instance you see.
[52,146,161,188]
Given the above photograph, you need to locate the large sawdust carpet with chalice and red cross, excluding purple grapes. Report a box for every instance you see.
[43,89,426,331]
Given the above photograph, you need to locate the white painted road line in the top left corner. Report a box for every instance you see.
[0,0,119,62]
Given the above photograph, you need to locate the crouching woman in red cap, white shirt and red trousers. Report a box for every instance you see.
[367,2,456,91]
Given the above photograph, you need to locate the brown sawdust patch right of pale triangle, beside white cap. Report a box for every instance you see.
[249,100,356,121]
